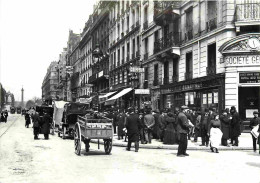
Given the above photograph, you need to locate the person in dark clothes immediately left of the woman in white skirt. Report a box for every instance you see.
[200,109,209,147]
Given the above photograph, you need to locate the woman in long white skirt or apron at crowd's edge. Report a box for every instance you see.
[208,115,223,153]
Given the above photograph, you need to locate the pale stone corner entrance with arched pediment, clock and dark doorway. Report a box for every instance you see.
[219,33,260,128]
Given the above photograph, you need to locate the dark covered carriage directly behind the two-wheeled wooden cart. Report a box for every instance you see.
[58,102,87,139]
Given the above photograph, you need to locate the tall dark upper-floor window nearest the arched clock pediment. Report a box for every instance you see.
[207,43,216,75]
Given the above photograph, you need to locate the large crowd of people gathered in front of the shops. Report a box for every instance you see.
[102,106,260,156]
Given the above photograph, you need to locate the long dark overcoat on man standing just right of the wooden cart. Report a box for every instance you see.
[126,114,141,142]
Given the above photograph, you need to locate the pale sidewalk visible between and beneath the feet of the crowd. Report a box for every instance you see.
[91,133,259,151]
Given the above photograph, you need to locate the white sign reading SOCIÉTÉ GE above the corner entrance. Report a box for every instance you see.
[225,55,260,67]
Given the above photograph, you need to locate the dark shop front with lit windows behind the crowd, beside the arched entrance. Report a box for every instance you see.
[161,74,225,112]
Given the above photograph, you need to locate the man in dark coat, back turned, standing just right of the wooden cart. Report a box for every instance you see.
[126,108,141,152]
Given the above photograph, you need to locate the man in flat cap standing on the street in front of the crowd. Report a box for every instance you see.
[177,106,190,157]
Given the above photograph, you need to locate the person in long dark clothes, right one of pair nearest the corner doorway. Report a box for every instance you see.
[230,106,241,146]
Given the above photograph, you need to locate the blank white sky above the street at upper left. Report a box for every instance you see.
[0,0,96,101]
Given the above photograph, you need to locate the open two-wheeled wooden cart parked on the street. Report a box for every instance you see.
[74,116,113,155]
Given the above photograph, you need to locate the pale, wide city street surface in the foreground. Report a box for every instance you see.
[0,114,260,183]
